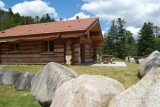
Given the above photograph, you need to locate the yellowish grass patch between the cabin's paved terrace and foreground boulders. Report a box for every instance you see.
[69,63,139,88]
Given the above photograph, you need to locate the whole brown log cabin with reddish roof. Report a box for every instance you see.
[0,18,104,64]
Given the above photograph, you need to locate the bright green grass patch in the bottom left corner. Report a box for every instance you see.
[0,84,40,107]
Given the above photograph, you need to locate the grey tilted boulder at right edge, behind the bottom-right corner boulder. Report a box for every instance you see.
[138,51,160,78]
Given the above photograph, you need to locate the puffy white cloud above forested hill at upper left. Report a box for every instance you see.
[12,0,58,17]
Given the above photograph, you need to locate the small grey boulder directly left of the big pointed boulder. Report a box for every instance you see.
[15,72,35,90]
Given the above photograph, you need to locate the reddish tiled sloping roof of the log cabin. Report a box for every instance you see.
[0,18,98,37]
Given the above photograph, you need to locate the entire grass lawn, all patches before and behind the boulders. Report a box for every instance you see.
[0,63,139,107]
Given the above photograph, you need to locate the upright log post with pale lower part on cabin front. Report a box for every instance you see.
[65,39,72,65]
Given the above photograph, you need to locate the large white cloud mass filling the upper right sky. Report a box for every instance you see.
[81,0,160,34]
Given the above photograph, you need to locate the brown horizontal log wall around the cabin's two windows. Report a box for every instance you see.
[0,40,65,64]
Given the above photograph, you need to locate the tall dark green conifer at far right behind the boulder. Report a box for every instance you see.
[137,22,156,56]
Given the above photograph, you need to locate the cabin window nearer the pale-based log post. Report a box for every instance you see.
[44,41,54,52]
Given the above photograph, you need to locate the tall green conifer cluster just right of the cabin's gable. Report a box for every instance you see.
[104,18,136,58]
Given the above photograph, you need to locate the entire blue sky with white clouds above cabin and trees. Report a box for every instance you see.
[0,0,160,38]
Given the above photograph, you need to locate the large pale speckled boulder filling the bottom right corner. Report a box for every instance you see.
[109,64,160,107]
